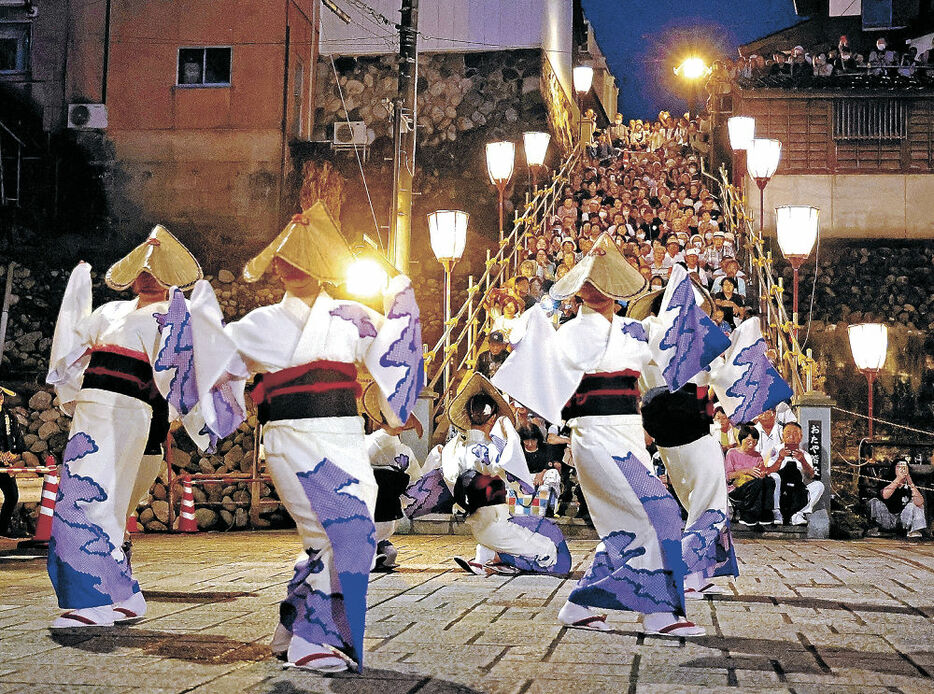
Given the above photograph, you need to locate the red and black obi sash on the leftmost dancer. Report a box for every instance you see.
[81,346,169,455]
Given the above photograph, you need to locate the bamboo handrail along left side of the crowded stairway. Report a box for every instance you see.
[425,148,581,422]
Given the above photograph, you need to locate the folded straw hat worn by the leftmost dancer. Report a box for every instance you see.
[104,224,204,291]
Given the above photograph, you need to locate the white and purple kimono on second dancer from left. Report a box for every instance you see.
[210,276,424,668]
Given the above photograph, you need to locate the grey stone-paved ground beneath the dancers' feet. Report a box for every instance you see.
[0,532,934,694]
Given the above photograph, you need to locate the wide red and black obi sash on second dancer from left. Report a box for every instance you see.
[253,361,361,424]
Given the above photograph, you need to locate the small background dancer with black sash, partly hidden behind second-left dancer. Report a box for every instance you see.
[363,383,422,571]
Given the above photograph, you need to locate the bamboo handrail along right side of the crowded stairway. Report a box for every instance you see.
[704,166,814,396]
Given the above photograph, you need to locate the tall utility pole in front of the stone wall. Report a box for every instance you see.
[389,0,418,273]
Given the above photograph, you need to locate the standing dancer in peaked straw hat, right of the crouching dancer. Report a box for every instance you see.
[493,234,722,636]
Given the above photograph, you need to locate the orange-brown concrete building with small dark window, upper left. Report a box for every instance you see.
[0,0,320,258]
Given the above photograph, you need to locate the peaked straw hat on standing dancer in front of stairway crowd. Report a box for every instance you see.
[548,232,646,300]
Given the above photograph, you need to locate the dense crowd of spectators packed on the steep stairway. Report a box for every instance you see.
[487,112,748,354]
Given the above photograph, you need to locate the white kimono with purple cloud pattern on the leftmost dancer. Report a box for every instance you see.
[46,264,242,609]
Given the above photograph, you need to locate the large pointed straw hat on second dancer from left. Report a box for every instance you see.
[243,200,354,284]
